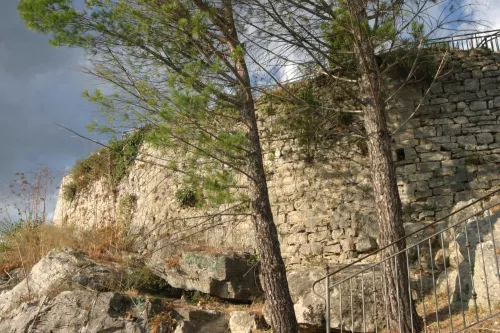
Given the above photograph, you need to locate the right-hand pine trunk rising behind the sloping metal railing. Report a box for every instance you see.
[346,0,422,333]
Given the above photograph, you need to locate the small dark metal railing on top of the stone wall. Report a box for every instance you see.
[425,29,500,51]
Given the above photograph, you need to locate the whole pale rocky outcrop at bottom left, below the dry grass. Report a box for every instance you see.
[0,248,262,333]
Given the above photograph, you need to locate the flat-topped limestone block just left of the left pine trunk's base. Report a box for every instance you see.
[149,244,261,300]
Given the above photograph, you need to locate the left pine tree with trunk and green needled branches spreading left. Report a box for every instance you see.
[19,0,298,333]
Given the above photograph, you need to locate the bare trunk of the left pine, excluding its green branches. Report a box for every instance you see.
[218,0,298,333]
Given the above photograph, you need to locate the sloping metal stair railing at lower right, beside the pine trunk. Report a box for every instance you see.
[313,190,500,333]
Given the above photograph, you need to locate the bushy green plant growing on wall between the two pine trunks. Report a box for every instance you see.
[260,75,364,162]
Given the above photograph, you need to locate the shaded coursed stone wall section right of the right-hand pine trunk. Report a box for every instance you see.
[393,50,500,220]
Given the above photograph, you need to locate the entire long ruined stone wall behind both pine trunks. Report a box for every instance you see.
[54,52,500,268]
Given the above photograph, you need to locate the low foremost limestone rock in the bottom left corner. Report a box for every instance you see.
[0,290,147,333]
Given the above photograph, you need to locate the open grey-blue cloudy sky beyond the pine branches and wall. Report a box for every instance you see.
[0,0,500,220]
